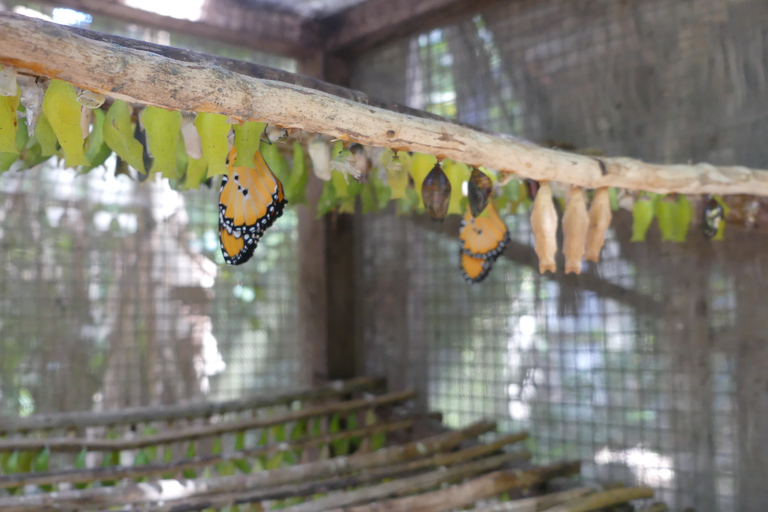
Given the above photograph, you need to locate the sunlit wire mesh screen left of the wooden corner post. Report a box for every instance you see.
[0,163,301,415]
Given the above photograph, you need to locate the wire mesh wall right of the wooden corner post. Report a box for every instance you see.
[353,0,768,512]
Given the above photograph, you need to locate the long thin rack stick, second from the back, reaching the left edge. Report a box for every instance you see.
[0,391,416,452]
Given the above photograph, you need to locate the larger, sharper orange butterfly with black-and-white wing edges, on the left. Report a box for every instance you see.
[219,147,287,265]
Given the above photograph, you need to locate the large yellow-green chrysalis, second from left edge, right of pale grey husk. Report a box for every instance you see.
[43,80,89,167]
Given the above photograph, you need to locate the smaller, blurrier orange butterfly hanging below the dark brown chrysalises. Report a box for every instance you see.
[459,203,509,283]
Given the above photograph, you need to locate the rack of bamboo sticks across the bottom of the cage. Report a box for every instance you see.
[0,379,652,512]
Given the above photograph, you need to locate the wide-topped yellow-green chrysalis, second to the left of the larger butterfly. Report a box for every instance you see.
[140,106,181,179]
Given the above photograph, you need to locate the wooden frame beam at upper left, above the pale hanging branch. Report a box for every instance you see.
[31,0,323,58]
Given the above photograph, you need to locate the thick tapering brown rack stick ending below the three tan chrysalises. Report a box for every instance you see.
[320,462,580,512]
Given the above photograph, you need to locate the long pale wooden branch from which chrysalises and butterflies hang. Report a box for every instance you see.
[0,13,768,196]
